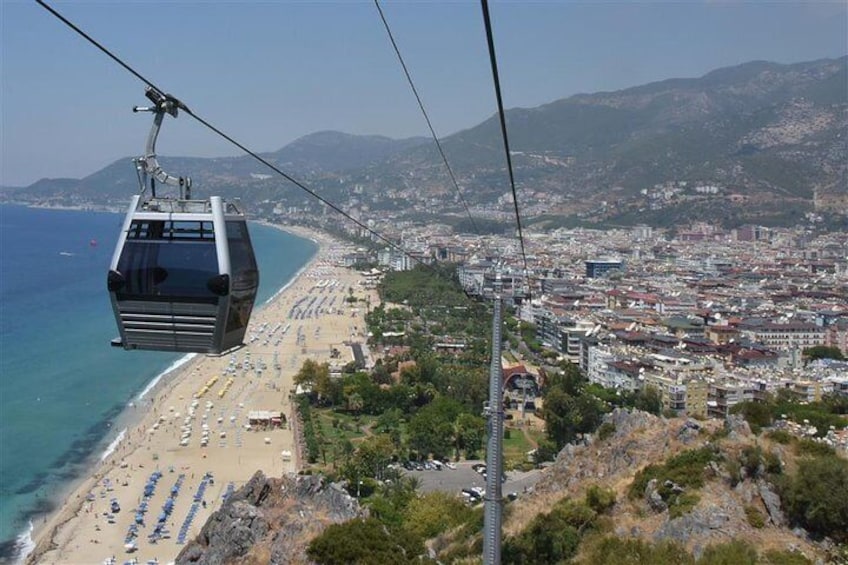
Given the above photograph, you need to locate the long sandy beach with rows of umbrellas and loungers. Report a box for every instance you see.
[27,228,376,564]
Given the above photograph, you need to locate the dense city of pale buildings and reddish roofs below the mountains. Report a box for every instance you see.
[322,216,848,448]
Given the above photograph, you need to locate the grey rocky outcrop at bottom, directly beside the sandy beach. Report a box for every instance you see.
[176,472,364,565]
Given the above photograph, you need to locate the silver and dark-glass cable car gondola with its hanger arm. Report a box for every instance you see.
[107,88,259,354]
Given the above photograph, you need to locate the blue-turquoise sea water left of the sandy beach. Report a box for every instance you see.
[0,205,317,563]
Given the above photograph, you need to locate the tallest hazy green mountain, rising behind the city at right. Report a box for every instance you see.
[366,57,848,223]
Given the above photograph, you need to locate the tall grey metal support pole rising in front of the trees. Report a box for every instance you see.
[483,273,503,565]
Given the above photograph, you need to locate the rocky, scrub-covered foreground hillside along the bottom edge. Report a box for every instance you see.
[177,409,848,563]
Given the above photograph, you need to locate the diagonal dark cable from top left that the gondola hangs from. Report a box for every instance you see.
[35,0,435,272]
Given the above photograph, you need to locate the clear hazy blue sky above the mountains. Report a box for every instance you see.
[0,0,848,185]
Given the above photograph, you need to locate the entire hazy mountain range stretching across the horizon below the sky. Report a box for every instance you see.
[0,56,848,225]
